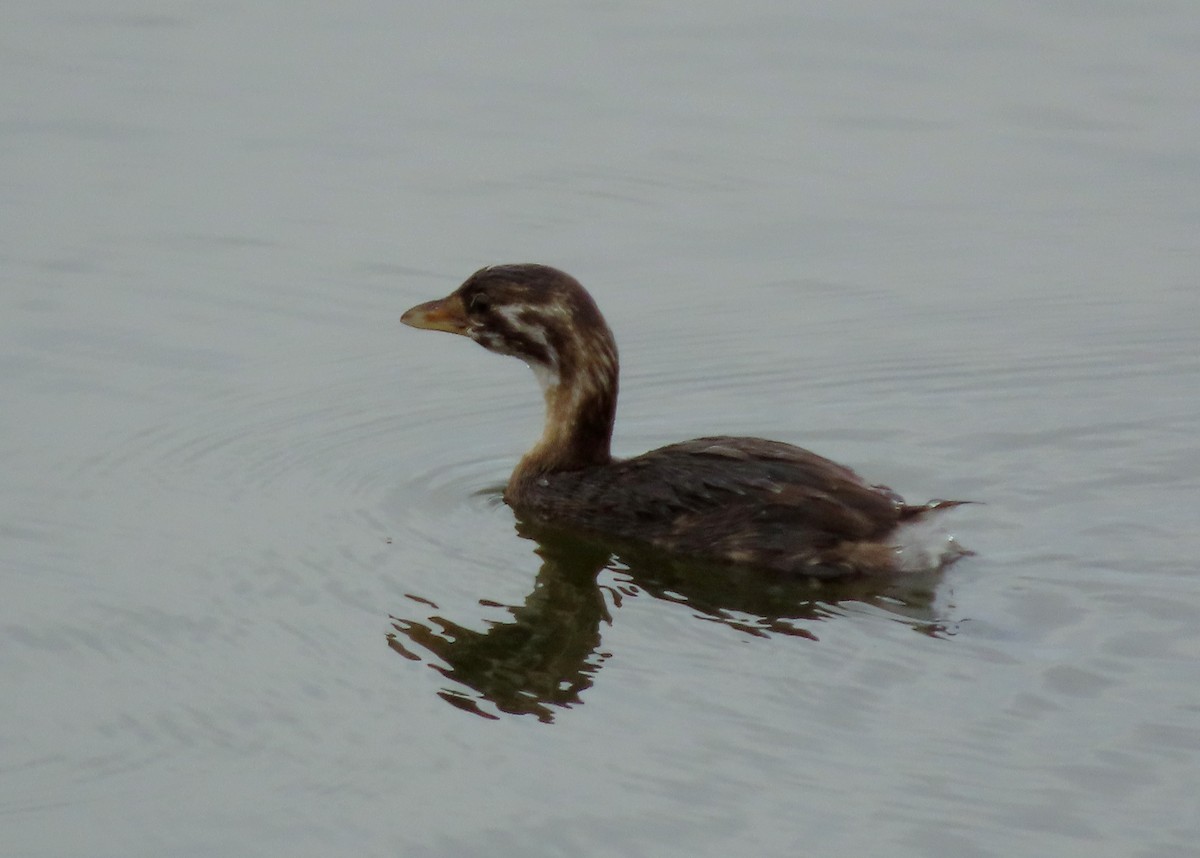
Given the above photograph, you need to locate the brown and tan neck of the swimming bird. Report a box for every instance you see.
[509,349,617,487]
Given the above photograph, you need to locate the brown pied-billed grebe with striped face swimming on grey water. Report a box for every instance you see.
[401,264,962,577]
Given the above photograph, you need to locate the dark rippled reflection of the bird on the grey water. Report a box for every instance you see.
[388,523,947,722]
